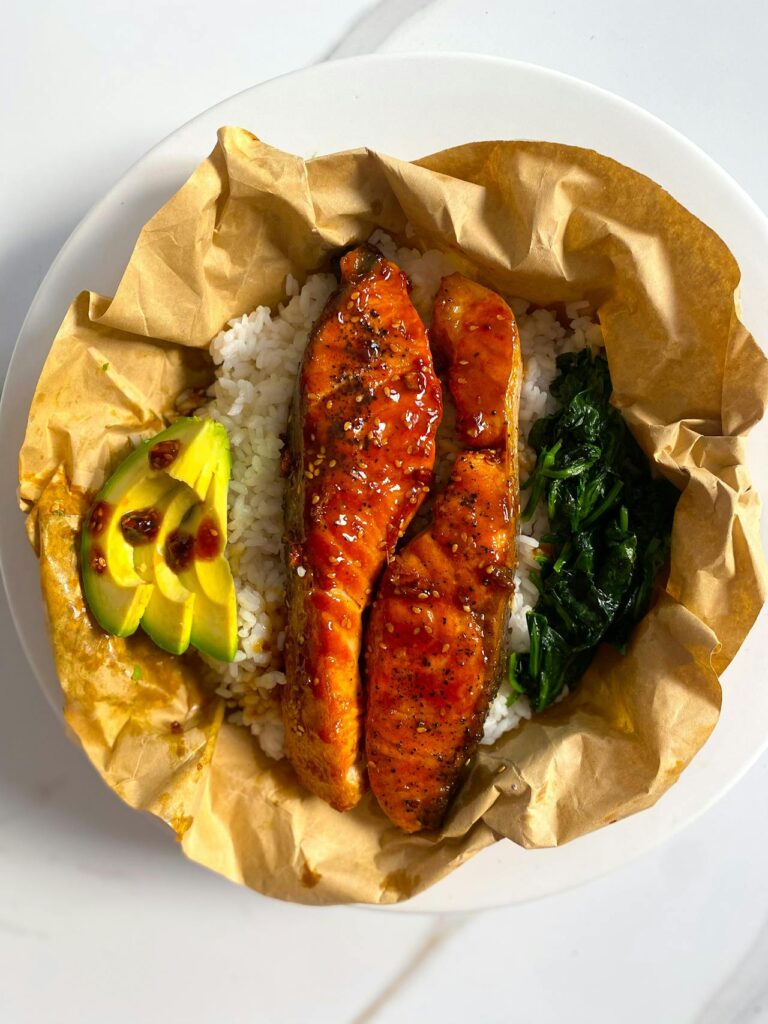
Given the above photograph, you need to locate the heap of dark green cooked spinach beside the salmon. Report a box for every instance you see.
[509,349,678,711]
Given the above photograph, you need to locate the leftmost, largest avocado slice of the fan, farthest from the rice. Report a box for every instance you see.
[81,417,230,652]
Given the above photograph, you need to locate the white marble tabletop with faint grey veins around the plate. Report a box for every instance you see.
[0,0,768,1024]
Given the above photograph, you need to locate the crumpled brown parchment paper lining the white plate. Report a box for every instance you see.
[20,128,768,903]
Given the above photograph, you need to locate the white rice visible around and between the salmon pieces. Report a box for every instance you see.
[203,231,602,758]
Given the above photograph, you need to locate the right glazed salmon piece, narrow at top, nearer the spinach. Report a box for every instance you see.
[366,274,521,833]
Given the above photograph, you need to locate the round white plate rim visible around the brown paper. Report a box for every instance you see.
[0,54,768,910]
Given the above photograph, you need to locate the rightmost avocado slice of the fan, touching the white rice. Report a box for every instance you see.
[177,468,238,662]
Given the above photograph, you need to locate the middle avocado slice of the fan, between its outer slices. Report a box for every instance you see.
[133,483,198,654]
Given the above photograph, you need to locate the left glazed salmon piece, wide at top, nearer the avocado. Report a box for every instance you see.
[282,246,442,811]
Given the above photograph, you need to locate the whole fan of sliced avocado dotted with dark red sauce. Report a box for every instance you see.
[81,417,238,660]
